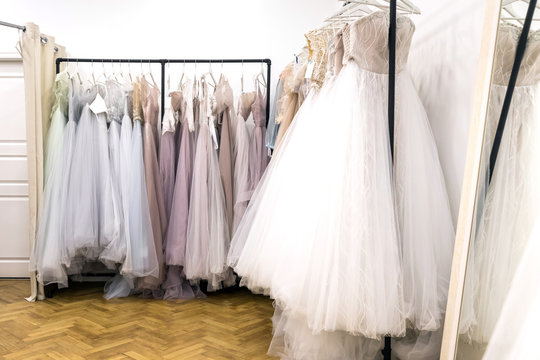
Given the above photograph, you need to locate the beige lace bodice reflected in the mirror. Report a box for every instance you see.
[493,24,540,86]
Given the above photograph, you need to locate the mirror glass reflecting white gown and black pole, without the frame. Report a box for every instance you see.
[457,0,540,360]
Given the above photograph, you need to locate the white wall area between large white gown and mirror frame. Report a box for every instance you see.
[408,0,486,223]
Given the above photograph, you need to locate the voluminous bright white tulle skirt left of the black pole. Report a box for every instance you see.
[229,63,405,338]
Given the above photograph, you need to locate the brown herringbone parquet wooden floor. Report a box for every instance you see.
[0,280,273,360]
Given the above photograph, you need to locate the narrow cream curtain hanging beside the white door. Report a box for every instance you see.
[19,23,65,301]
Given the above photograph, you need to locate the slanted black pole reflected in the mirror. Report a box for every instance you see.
[489,0,536,182]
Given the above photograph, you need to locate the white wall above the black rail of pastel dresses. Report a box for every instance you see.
[0,0,341,97]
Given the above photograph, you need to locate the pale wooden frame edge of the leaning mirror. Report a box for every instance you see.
[440,0,502,360]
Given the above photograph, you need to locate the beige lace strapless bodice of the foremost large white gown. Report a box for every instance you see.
[343,11,415,74]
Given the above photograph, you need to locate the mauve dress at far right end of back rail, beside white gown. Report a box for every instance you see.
[249,85,268,191]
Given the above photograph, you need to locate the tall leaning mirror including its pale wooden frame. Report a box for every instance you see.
[441,0,540,360]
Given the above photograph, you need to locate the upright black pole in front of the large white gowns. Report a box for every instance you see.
[388,0,396,160]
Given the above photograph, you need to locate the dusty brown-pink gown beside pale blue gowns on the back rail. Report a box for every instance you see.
[138,78,167,296]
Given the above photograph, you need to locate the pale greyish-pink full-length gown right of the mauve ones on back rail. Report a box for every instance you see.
[185,79,235,291]
